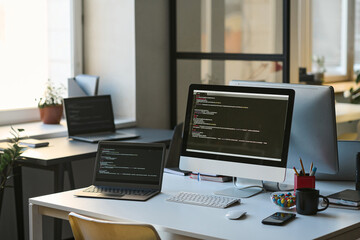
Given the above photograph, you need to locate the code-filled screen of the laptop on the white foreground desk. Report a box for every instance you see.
[93,141,165,187]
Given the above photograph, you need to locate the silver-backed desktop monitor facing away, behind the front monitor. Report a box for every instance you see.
[230,80,339,174]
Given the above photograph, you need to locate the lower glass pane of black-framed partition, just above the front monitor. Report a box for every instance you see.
[176,60,283,122]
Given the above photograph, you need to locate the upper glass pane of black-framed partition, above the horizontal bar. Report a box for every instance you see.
[176,0,283,54]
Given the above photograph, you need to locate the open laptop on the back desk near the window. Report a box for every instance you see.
[64,95,138,143]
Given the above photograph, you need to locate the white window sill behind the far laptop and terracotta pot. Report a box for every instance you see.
[0,118,136,142]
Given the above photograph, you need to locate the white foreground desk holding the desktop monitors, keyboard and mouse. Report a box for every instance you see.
[29,174,360,240]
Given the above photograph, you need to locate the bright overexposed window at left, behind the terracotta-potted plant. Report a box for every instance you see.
[0,0,81,124]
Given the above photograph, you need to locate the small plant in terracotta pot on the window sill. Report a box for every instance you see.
[38,79,65,124]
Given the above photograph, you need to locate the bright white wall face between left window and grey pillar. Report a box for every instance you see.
[83,0,136,121]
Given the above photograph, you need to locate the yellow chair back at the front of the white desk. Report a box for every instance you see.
[69,212,160,240]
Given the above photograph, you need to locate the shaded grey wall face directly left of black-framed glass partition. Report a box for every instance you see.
[135,0,170,128]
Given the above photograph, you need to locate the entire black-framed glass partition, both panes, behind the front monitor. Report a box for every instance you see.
[170,0,290,126]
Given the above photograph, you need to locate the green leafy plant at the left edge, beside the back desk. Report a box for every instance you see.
[0,127,25,215]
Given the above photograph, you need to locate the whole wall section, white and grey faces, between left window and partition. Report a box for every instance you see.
[83,0,170,128]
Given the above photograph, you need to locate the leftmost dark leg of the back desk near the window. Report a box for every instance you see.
[13,165,25,239]
